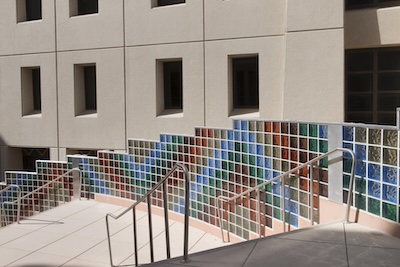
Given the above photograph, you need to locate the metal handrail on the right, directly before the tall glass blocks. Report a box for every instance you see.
[217,147,356,242]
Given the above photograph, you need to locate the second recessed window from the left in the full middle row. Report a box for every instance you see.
[74,64,97,116]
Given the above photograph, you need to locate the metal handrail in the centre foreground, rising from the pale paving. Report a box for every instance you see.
[106,163,190,267]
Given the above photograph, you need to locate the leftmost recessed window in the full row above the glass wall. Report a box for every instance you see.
[21,67,42,116]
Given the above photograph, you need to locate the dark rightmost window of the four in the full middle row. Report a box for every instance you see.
[232,56,258,108]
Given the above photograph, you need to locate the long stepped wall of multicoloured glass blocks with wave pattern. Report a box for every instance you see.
[6,120,400,239]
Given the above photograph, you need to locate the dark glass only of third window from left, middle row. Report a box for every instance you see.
[163,60,182,109]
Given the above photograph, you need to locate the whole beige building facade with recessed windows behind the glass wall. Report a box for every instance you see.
[0,0,400,176]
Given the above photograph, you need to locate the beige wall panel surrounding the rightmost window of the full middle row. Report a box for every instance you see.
[205,37,284,127]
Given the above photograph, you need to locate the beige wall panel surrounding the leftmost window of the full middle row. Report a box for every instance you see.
[0,53,57,147]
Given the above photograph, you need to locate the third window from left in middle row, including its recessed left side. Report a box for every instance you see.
[157,59,183,115]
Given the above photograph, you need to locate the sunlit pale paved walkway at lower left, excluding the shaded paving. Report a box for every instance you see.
[0,200,230,267]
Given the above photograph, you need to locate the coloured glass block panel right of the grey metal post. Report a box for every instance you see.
[343,126,400,222]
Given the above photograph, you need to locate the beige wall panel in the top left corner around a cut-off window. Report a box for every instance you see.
[0,0,55,55]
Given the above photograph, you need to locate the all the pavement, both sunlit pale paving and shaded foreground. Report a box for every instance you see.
[0,200,400,267]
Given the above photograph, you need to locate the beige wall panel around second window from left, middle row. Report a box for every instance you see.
[57,48,126,149]
